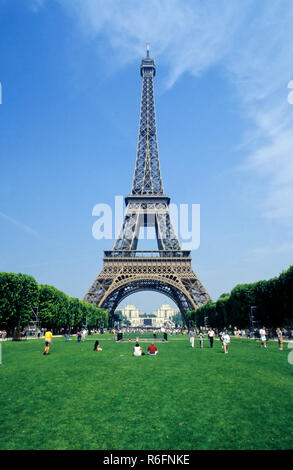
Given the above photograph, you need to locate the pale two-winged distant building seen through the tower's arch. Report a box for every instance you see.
[117,304,179,328]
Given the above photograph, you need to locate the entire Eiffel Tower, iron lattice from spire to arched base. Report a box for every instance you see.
[84,46,211,316]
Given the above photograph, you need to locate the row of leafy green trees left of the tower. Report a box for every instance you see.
[0,272,108,333]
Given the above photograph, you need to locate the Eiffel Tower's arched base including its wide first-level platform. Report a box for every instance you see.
[84,250,210,315]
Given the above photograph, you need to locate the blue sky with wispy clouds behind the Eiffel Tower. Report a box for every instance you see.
[0,0,293,312]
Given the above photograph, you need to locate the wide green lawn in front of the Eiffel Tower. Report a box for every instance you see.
[0,335,293,450]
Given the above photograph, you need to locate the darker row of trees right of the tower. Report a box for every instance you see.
[186,265,293,329]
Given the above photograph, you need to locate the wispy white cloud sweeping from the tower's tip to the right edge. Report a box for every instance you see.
[30,0,293,228]
